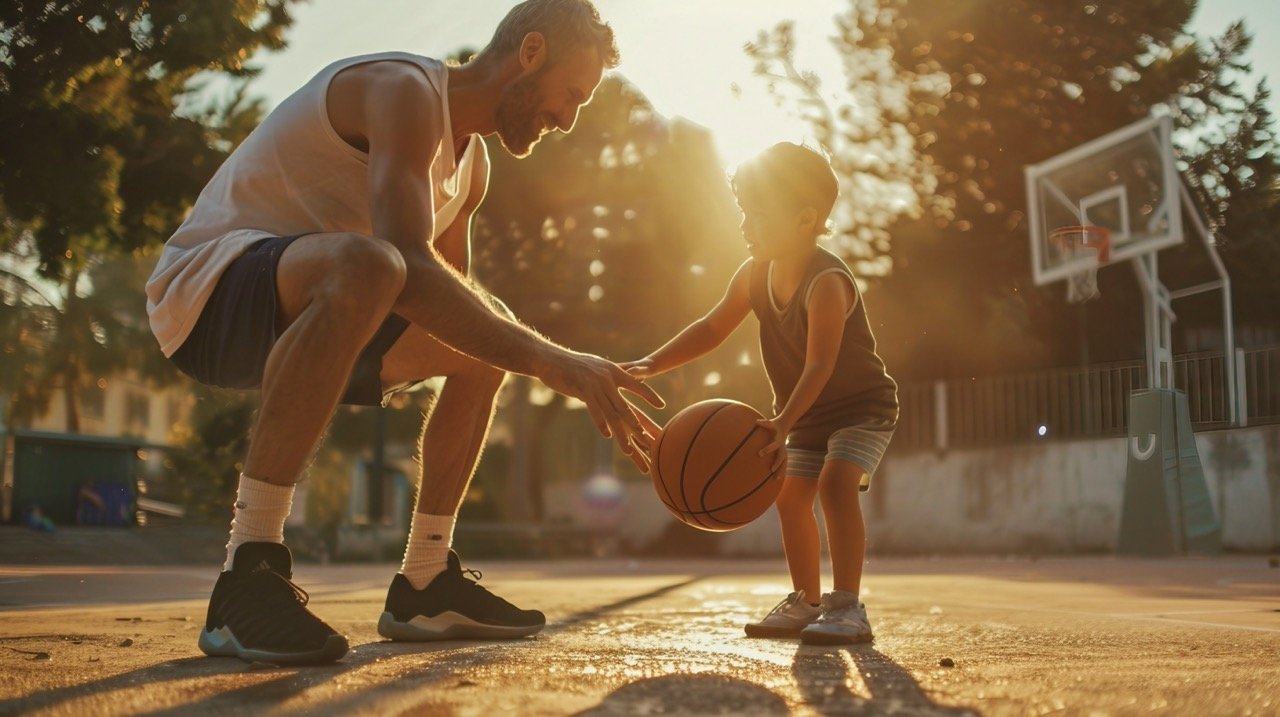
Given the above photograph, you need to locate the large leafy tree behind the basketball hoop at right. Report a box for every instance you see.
[747,0,1275,378]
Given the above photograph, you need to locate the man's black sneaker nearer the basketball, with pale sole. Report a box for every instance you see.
[378,551,547,641]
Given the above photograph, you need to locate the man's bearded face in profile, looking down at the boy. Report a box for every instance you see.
[495,47,604,157]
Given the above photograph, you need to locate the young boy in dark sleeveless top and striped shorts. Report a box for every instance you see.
[623,142,897,644]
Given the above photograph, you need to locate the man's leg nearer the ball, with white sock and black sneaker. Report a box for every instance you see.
[378,325,547,640]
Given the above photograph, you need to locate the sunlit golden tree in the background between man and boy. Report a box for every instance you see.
[474,74,759,520]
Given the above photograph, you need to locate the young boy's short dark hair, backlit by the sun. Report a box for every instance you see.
[732,142,840,232]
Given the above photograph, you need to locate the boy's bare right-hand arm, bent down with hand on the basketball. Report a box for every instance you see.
[760,273,858,467]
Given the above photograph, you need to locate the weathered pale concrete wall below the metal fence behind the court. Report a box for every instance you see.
[547,425,1280,556]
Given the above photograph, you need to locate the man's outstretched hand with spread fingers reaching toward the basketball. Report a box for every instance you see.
[538,352,666,472]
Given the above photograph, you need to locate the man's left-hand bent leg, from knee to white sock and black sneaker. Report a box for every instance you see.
[200,234,404,663]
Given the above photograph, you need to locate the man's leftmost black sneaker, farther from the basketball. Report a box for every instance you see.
[200,543,347,665]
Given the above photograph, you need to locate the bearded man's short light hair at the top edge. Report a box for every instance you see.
[481,0,618,68]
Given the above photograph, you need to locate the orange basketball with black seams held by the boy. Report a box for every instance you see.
[650,398,782,531]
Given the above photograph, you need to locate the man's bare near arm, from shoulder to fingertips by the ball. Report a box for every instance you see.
[328,61,662,453]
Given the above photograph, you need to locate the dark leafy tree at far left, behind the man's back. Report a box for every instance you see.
[0,0,299,430]
